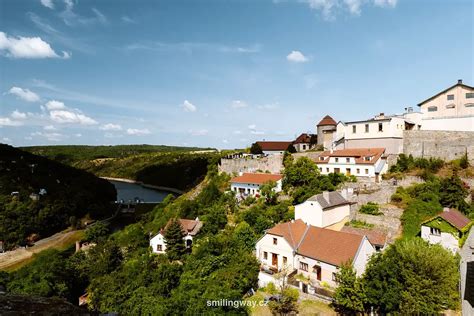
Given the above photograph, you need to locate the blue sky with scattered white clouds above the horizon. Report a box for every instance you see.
[0,0,474,148]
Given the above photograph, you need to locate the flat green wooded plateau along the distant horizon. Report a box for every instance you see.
[21,145,213,164]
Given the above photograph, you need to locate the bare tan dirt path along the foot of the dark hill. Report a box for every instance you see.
[0,230,83,270]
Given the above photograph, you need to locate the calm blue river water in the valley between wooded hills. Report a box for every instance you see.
[109,180,169,202]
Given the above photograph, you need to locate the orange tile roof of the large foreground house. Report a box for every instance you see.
[267,219,364,266]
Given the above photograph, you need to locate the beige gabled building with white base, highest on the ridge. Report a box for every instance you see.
[418,80,474,131]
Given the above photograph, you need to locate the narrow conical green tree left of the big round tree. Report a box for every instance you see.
[334,263,365,315]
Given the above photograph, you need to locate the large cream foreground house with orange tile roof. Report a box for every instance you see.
[256,219,375,293]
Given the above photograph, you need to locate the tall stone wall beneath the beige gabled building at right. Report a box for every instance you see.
[403,127,474,163]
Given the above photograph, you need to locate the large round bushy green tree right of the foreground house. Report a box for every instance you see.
[363,238,459,315]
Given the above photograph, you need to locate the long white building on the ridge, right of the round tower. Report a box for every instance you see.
[333,112,421,155]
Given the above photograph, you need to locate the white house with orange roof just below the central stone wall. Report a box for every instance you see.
[230,173,283,198]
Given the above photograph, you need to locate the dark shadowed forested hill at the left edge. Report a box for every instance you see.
[0,144,116,248]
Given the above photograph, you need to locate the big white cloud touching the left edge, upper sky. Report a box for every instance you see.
[0,32,70,59]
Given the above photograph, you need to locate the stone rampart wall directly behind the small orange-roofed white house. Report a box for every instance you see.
[219,155,283,174]
